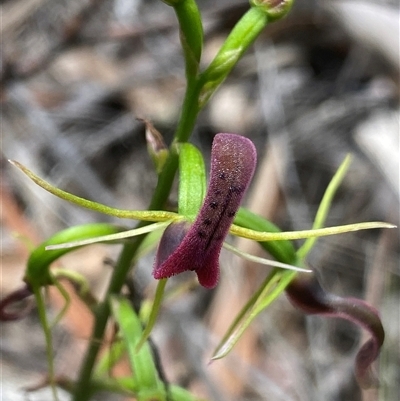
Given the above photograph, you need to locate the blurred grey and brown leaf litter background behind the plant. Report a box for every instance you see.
[0,0,400,401]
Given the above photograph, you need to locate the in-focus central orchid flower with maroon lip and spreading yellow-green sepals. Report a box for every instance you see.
[25,133,391,288]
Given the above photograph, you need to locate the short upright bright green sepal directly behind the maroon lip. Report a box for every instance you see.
[178,143,207,221]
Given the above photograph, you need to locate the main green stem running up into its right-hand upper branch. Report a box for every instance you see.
[73,4,276,401]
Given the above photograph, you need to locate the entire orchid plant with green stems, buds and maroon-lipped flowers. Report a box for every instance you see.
[0,0,393,401]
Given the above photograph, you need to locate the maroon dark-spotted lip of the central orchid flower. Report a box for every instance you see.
[153,134,257,288]
